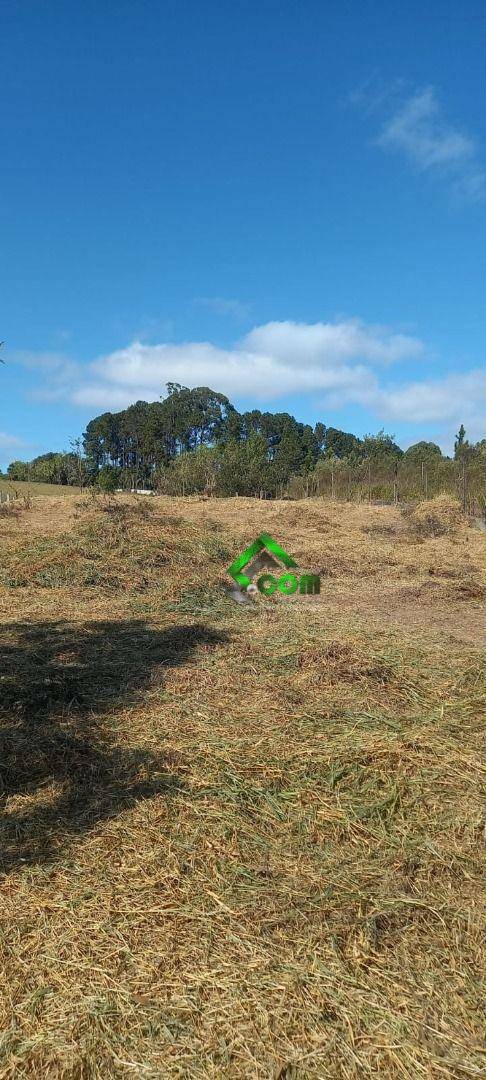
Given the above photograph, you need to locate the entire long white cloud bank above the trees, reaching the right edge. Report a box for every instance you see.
[14,319,486,437]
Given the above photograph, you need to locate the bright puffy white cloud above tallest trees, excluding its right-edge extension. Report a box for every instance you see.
[61,320,424,408]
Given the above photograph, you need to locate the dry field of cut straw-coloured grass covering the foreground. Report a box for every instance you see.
[0,485,486,1080]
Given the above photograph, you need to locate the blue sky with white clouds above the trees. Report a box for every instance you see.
[0,0,486,465]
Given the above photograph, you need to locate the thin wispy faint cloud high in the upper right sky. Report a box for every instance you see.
[352,86,486,202]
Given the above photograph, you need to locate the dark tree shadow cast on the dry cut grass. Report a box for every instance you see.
[0,620,227,873]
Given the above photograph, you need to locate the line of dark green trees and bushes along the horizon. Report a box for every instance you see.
[8,382,486,507]
